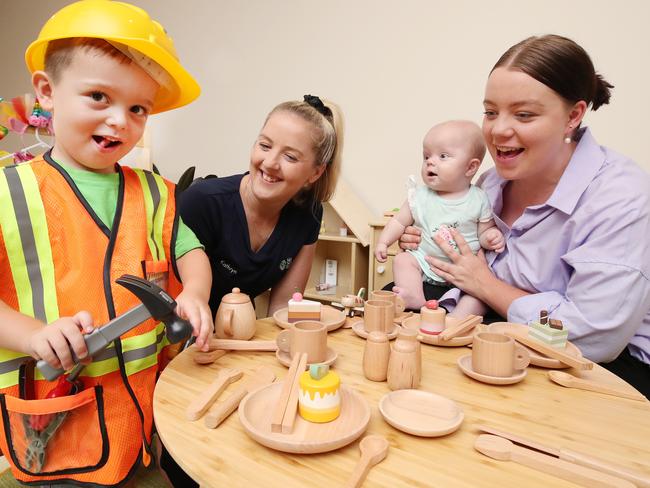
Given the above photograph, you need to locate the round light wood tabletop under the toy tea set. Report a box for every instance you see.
[154,319,650,488]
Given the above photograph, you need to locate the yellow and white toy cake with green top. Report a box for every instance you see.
[298,364,341,423]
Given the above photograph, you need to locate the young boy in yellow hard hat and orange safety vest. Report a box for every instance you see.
[0,0,212,486]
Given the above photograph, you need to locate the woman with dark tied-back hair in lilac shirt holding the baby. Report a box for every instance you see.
[402,35,650,397]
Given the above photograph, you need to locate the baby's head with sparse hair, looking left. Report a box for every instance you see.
[422,125,473,193]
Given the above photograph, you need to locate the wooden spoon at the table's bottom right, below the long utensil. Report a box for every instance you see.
[474,434,635,488]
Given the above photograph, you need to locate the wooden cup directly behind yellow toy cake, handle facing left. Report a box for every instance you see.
[276,320,327,364]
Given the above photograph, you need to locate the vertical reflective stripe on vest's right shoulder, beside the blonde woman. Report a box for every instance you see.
[132,168,168,261]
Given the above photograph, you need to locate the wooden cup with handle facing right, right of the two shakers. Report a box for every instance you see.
[472,332,530,378]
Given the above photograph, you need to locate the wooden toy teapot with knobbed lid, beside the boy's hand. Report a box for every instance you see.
[214,288,257,341]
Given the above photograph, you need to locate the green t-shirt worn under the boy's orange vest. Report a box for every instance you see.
[57,161,203,259]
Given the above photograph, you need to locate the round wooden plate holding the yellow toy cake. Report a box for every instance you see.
[239,382,370,454]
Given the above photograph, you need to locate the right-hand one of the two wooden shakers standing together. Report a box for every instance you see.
[387,329,422,390]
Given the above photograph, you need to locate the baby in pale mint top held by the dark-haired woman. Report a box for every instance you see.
[375,120,505,317]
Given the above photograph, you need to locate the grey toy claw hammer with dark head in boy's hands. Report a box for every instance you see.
[36,275,192,381]
